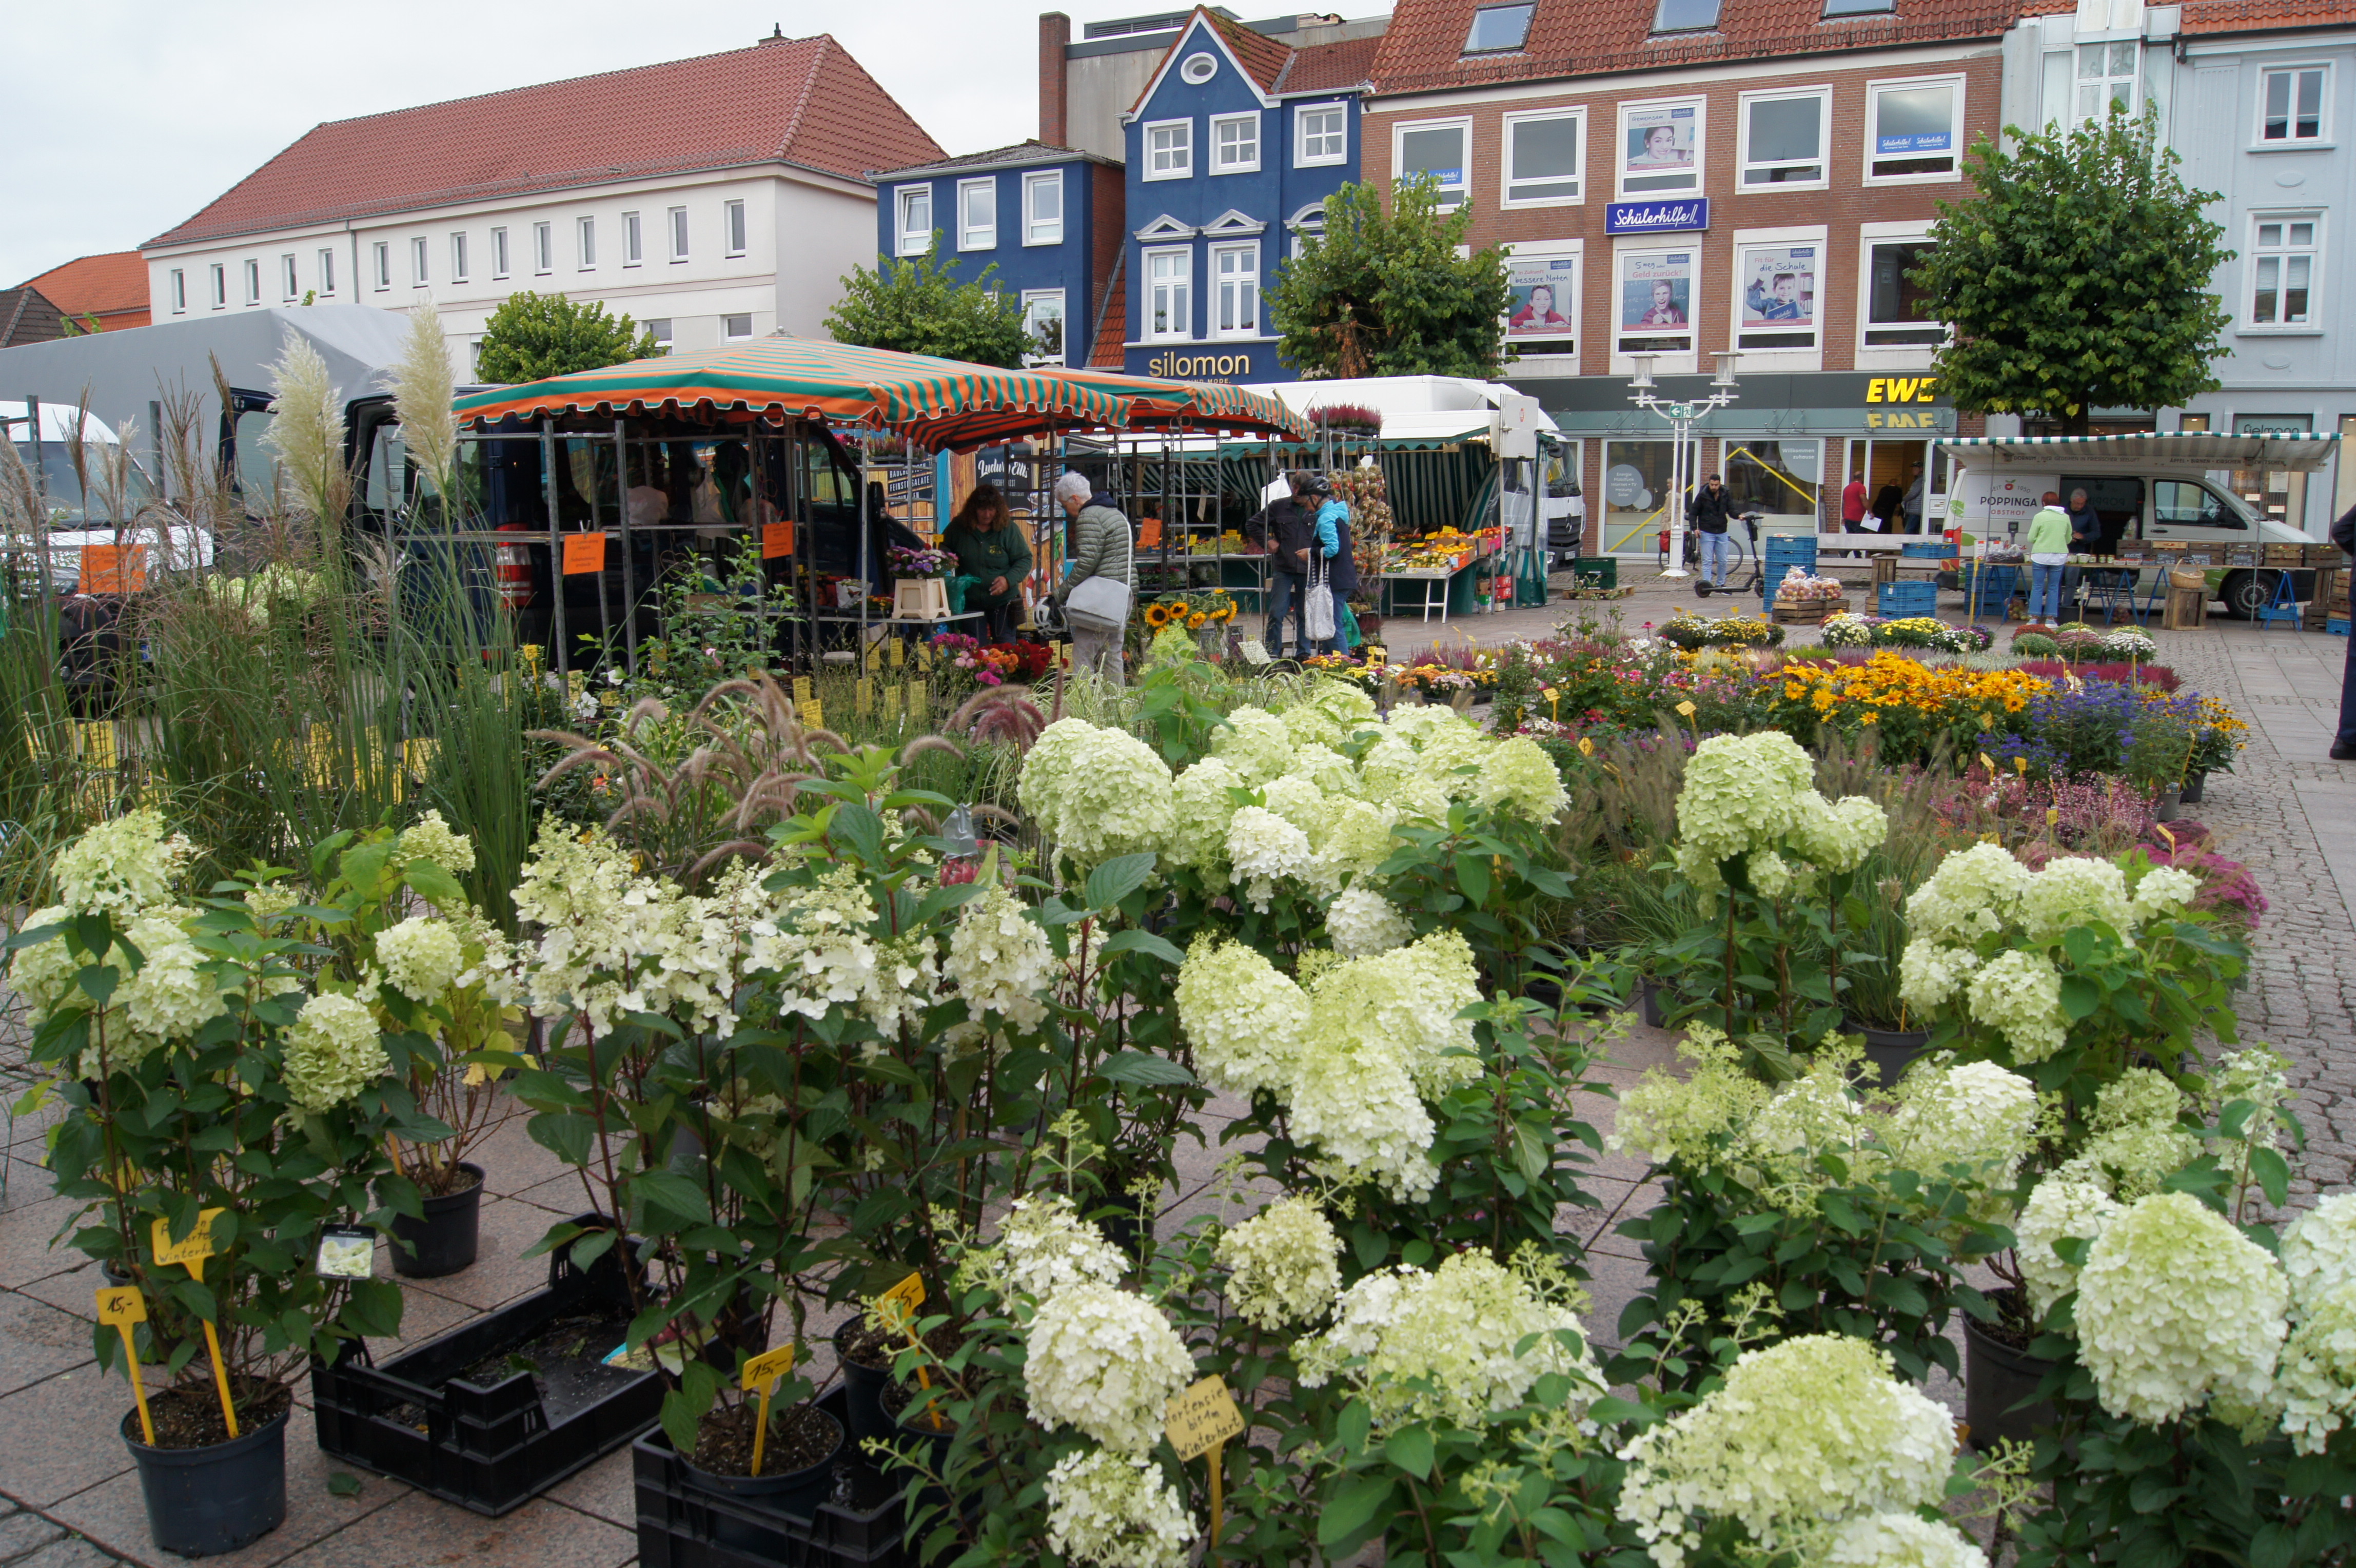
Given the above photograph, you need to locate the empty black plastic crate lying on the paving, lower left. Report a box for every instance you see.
[311,1215,662,1519]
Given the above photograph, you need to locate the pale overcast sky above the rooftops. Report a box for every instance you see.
[0,0,1390,287]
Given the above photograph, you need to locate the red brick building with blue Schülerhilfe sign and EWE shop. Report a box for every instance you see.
[1362,0,2019,556]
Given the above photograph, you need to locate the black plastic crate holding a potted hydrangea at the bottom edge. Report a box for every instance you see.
[629,1389,916,1568]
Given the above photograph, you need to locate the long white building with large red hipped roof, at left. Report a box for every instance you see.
[142,33,943,375]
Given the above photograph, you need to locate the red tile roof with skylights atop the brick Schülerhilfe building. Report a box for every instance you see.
[1373,0,2016,94]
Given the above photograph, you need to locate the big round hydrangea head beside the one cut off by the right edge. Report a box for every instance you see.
[2076,1191,2290,1424]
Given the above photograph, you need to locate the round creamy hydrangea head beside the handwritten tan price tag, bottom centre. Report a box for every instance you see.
[1023,1281,1194,1455]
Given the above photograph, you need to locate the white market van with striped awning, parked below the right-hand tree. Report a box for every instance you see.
[1939,431,2340,619]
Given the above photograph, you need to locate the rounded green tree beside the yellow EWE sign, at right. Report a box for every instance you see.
[1909,108,2233,436]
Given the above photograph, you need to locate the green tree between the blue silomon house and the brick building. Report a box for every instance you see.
[1267,174,1510,381]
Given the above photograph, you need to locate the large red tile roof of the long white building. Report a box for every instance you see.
[148,33,943,247]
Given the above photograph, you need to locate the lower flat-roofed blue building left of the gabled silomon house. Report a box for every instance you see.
[869,141,1124,365]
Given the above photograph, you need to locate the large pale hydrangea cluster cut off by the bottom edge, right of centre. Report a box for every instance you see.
[1619,1335,1955,1568]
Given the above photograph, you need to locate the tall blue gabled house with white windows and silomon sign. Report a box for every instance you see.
[1116,9,1381,381]
